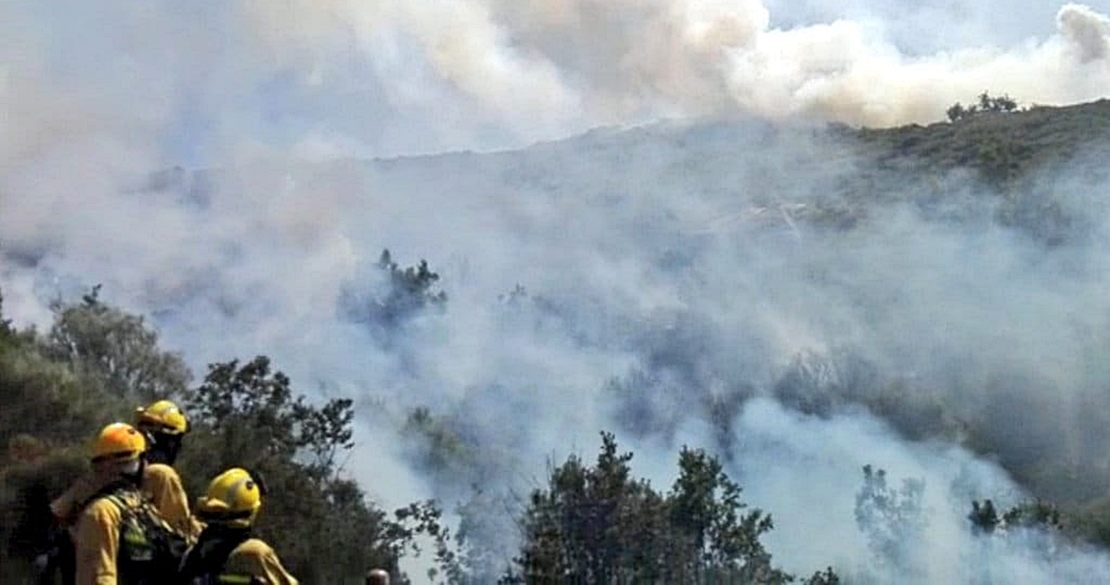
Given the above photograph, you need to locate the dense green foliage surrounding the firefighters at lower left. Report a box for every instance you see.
[0,281,442,584]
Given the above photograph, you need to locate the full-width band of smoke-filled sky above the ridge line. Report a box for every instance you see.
[0,0,1110,159]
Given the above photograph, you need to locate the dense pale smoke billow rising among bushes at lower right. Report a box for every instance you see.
[723,399,1110,584]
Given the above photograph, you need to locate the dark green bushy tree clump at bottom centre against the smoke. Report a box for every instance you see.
[503,433,812,583]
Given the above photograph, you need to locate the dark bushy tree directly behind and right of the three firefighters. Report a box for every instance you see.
[180,356,396,583]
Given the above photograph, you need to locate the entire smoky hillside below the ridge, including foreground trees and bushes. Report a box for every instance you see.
[0,100,1110,583]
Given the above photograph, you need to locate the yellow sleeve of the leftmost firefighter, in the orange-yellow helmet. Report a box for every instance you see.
[73,500,122,585]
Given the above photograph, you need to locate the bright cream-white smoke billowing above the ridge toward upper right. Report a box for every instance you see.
[227,0,1110,138]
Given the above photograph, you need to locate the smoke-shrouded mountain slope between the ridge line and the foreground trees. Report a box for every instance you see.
[3,103,1110,578]
